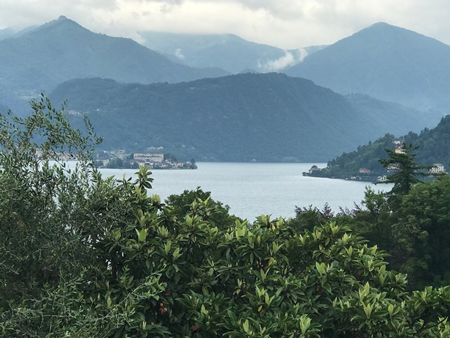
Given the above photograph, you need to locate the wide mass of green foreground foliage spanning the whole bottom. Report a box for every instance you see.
[0,98,450,338]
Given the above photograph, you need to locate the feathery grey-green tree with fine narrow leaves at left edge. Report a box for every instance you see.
[0,96,100,306]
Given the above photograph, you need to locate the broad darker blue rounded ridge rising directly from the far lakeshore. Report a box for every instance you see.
[50,73,432,162]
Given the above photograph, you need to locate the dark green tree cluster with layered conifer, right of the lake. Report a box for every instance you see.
[293,170,450,289]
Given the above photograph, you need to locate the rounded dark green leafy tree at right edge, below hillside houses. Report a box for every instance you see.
[393,175,450,287]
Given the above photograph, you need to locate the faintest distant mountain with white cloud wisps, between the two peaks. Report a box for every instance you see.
[140,32,322,74]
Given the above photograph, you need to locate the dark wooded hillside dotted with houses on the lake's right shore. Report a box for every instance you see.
[315,115,450,178]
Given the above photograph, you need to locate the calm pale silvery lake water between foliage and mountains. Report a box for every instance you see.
[97,163,391,221]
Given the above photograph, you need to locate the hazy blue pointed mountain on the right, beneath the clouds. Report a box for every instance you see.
[286,23,450,112]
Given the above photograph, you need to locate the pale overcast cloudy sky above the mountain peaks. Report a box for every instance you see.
[0,0,450,49]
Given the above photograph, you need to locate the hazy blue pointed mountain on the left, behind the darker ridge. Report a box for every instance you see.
[0,16,227,115]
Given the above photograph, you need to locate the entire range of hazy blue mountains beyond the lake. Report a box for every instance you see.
[0,17,450,161]
